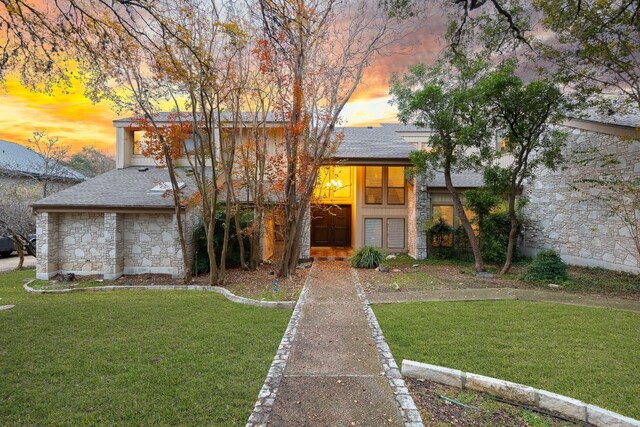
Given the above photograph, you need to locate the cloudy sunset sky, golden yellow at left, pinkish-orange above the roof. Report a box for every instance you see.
[0,12,442,155]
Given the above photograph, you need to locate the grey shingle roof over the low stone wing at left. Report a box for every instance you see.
[32,167,193,208]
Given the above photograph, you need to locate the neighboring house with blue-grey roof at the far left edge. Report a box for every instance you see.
[0,140,86,193]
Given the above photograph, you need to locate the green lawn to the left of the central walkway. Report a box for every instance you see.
[0,271,291,426]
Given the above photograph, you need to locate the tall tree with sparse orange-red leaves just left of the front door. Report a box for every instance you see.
[259,0,396,276]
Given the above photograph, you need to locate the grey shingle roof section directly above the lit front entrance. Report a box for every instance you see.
[333,126,413,164]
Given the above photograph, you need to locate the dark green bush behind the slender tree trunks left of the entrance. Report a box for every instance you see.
[193,210,253,273]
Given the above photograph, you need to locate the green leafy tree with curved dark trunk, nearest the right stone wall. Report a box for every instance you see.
[479,61,570,274]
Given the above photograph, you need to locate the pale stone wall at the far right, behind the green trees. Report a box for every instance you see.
[523,129,640,273]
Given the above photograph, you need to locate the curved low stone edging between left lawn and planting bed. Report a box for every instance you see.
[23,279,296,309]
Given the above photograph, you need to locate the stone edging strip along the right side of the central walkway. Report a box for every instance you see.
[351,268,424,427]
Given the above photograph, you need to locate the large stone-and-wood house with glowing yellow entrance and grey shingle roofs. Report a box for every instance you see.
[33,110,640,279]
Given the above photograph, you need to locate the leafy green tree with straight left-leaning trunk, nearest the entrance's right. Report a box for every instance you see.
[390,56,493,272]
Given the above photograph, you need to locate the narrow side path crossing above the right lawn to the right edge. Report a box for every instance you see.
[367,288,640,311]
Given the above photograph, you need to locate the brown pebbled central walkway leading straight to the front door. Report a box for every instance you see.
[269,261,404,426]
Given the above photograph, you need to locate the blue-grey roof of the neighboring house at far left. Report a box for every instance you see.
[0,140,86,181]
